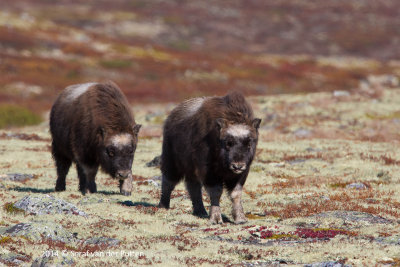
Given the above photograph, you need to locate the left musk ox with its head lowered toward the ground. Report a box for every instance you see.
[50,82,141,195]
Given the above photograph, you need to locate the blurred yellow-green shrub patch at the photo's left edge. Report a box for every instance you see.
[0,104,42,129]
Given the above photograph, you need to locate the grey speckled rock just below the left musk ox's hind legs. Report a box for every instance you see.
[14,195,87,216]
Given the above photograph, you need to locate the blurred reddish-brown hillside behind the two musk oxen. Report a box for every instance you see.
[0,0,400,124]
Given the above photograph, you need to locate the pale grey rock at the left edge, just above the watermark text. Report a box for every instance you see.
[3,221,75,243]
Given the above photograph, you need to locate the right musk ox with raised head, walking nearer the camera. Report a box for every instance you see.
[159,92,261,224]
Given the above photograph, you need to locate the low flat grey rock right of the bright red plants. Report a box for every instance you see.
[311,213,391,224]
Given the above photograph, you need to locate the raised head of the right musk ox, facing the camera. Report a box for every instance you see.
[217,118,261,174]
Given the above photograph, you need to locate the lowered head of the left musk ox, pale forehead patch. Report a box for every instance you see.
[99,124,141,180]
